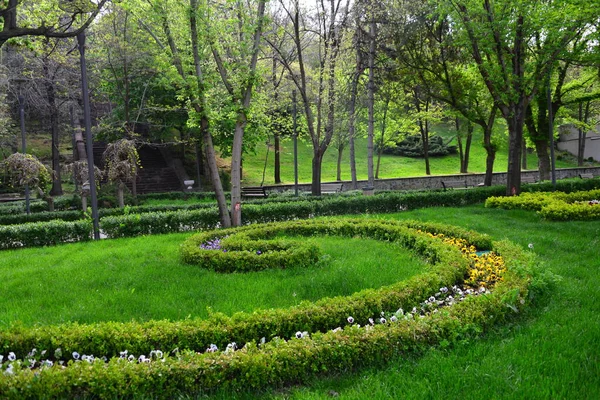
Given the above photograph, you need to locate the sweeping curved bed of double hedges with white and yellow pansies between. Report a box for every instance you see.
[0,219,532,398]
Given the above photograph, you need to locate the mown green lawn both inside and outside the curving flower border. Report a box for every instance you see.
[0,206,600,400]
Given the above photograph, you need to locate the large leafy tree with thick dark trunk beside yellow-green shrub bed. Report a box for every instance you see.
[440,0,600,195]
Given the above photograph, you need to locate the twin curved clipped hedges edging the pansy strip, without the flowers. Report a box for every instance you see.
[0,220,533,398]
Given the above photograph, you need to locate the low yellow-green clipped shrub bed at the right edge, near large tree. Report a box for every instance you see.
[485,189,600,221]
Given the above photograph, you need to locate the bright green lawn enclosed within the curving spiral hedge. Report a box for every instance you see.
[0,234,425,327]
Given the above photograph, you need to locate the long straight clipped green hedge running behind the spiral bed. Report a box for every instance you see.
[0,179,600,249]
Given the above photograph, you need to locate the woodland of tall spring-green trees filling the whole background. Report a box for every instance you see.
[0,0,600,226]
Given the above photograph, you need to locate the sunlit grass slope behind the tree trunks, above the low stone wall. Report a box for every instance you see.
[232,127,576,186]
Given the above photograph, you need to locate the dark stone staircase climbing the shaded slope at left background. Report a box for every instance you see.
[94,142,182,194]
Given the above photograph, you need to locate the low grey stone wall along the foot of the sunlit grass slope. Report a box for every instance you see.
[265,167,600,192]
